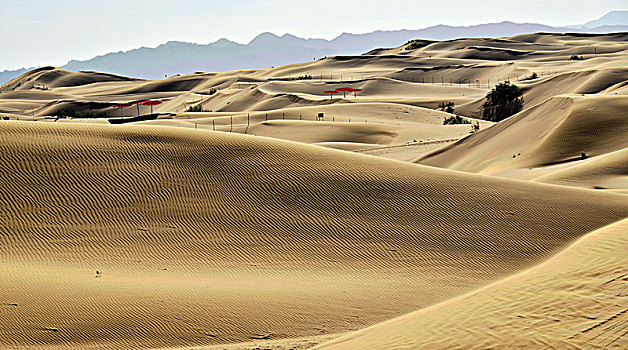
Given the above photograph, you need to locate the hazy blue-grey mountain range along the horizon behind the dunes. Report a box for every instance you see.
[0,11,628,84]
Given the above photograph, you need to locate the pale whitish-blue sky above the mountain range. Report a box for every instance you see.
[0,0,626,71]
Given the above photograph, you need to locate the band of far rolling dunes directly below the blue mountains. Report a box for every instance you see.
[0,33,628,123]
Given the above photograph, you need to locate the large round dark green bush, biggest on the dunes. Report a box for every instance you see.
[482,81,523,122]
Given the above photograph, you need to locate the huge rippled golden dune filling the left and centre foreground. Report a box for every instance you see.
[0,122,628,348]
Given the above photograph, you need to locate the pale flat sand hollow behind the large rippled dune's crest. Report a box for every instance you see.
[139,103,493,161]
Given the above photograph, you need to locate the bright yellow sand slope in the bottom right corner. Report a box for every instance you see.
[316,219,628,349]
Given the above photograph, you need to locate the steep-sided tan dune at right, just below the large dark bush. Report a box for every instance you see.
[417,96,628,174]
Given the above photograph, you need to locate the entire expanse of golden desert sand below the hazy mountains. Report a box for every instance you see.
[0,33,628,349]
